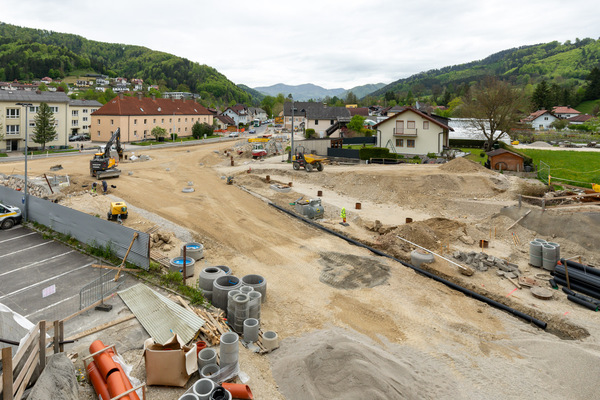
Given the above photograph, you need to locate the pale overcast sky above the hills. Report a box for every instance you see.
[0,0,600,89]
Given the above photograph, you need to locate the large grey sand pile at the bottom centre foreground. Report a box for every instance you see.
[271,328,456,400]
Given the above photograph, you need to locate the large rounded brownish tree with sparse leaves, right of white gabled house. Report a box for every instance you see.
[461,77,524,149]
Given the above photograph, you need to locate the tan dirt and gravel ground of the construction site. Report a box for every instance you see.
[0,142,600,399]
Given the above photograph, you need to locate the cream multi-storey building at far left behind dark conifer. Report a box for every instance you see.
[0,90,70,151]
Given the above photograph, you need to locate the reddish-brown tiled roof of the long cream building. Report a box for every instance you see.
[92,96,212,115]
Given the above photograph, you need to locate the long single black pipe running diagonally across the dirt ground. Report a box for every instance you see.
[269,203,548,329]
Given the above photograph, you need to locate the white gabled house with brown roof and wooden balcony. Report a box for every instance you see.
[374,107,453,156]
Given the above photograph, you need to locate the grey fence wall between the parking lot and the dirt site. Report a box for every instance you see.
[0,185,150,269]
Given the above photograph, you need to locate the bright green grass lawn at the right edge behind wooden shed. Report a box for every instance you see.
[519,149,600,187]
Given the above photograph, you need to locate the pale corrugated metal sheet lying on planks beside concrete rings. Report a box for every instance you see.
[119,283,204,344]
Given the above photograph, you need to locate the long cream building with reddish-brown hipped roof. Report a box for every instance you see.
[90,94,213,143]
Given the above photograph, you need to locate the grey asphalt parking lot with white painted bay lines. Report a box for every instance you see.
[0,225,131,323]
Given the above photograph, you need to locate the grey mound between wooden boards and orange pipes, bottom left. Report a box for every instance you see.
[28,353,79,400]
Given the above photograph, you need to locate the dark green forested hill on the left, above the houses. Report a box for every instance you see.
[0,22,252,104]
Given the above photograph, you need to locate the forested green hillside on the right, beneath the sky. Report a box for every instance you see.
[371,38,600,102]
